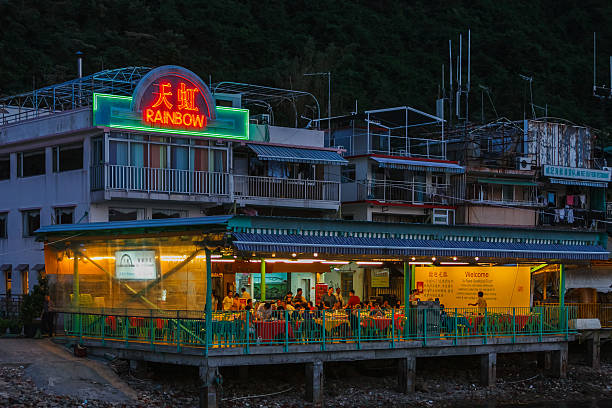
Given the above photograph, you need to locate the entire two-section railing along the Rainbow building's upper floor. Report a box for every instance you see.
[91,164,340,203]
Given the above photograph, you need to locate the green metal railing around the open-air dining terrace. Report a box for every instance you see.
[60,306,576,354]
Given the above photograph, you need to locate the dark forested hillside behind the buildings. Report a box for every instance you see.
[0,0,612,139]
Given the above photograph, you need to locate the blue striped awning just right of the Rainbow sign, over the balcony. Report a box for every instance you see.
[248,144,348,165]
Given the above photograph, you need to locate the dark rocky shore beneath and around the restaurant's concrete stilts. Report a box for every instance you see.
[0,349,612,408]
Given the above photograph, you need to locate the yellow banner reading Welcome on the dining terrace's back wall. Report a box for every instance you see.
[415,266,531,308]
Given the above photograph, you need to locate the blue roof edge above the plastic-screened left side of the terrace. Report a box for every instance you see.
[35,215,233,236]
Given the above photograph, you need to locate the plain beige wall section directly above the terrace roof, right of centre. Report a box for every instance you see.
[461,206,537,227]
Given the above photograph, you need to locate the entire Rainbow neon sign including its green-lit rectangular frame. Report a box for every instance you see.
[93,65,249,140]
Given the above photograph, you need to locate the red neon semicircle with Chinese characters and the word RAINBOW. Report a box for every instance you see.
[142,77,208,129]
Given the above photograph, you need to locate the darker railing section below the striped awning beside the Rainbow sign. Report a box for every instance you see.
[234,175,340,201]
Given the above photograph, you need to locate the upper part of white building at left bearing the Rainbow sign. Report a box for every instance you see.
[0,66,347,295]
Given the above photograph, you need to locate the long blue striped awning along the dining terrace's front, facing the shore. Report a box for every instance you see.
[233,233,609,260]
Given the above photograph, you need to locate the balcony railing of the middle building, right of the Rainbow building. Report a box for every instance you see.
[357,180,458,205]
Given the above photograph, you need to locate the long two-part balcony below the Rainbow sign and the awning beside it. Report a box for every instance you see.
[91,164,340,209]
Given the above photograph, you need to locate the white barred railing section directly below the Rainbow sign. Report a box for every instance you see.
[91,164,230,195]
